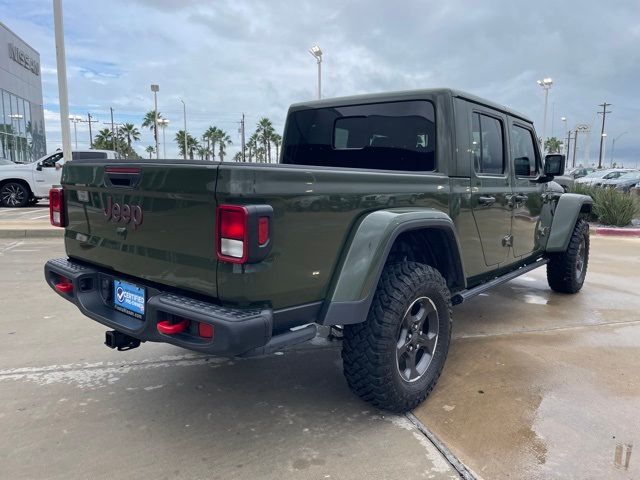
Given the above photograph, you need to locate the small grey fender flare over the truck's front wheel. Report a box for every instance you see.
[546,193,593,252]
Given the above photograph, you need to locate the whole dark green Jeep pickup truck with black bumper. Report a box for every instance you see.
[45,89,592,411]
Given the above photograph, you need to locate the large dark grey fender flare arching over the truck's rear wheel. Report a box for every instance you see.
[318,208,466,325]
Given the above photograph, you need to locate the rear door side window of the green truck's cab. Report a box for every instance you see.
[471,113,504,175]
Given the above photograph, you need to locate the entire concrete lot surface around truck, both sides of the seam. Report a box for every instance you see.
[0,237,640,479]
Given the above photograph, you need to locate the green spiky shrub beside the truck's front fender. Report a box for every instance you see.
[571,184,639,227]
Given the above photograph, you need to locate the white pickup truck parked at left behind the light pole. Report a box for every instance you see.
[0,150,120,207]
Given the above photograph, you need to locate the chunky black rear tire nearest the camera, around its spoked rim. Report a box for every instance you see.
[342,261,451,412]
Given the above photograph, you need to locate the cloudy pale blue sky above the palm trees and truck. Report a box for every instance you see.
[0,0,640,166]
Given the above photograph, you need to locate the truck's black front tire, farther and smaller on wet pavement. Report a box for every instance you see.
[547,218,589,293]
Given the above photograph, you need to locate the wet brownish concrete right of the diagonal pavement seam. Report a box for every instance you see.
[415,237,640,479]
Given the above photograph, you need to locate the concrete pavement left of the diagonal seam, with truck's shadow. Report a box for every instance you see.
[0,239,459,480]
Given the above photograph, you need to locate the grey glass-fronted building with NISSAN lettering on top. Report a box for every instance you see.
[0,22,47,163]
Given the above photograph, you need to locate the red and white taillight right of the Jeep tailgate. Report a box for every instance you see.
[216,205,249,263]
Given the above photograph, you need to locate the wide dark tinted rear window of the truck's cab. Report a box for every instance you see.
[282,100,436,172]
